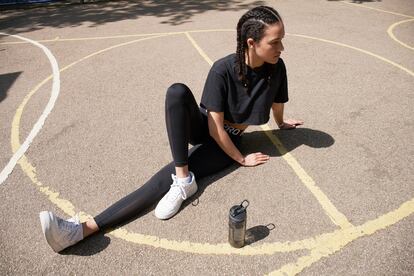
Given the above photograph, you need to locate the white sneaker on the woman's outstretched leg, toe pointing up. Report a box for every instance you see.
[39,211,83,252]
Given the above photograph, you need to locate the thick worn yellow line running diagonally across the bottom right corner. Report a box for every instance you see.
[269,198,414,275]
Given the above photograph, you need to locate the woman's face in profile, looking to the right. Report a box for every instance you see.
[247,22,285,64]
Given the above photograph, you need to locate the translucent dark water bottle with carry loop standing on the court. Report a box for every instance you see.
[229,200,249,248]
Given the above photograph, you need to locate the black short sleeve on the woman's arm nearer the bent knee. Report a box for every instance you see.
[200,69,226,112]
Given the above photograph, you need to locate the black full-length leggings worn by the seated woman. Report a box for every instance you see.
[94,83,240,230]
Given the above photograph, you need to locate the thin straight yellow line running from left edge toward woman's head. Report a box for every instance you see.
[0,29,234,45]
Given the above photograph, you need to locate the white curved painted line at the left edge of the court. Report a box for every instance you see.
[0,32,60,185]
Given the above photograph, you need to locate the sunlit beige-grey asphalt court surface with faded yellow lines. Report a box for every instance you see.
[0,1,414,275]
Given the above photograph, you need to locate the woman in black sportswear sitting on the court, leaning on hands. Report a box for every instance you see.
[40,6,303,252]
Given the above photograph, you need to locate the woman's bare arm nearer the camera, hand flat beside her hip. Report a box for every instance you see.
[208,111,269,167]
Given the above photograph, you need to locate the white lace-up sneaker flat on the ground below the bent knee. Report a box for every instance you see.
[155,172,197,219]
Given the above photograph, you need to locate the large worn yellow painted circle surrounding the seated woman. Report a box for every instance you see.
[12,30,414,274]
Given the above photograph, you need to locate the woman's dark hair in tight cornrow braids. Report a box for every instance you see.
[236,6,282,87]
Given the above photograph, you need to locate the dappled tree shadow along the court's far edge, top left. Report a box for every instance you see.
[0,0,264,34]
